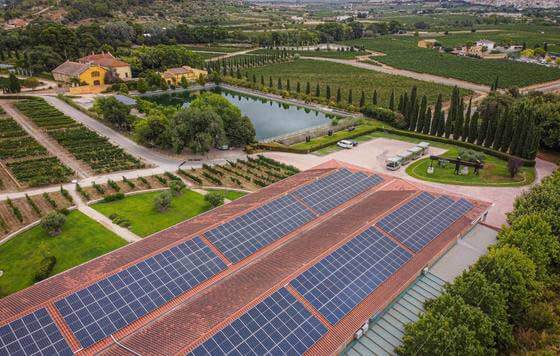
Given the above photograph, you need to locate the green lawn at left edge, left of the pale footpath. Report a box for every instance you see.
[0,211,126,294]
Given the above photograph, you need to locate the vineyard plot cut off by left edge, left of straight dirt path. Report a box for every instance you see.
[0,107,73,191]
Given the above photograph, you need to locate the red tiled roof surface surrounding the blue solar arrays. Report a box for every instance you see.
[0,161,490,355]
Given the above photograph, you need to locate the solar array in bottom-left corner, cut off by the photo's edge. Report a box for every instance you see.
[0,308,73,355]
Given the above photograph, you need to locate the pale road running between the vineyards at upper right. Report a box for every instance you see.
[301,57,490,93]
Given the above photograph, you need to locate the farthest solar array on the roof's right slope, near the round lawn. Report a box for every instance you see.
[378,193,473,252]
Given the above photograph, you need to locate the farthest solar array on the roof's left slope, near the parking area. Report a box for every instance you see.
[294,169,383,213]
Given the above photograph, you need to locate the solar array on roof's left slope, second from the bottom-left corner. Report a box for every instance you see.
[55,237,226,347]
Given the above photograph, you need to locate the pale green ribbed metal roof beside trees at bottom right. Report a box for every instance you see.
[343,271,446,356]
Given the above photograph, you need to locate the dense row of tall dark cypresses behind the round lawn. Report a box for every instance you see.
[398,87,540,159]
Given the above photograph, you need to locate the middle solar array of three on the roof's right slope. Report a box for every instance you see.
[291,227,412,325]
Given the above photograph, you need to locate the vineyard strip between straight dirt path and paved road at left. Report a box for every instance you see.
[16,99,144,174]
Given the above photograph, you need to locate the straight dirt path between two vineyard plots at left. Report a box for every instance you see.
[0,102,92,178]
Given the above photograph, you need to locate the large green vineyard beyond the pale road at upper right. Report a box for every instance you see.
[348,33,560,88]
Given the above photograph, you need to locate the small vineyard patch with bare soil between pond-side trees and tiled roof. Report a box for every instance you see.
[178,156,299,191]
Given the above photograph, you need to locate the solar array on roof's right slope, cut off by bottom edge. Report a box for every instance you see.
[192,288,327,356]
